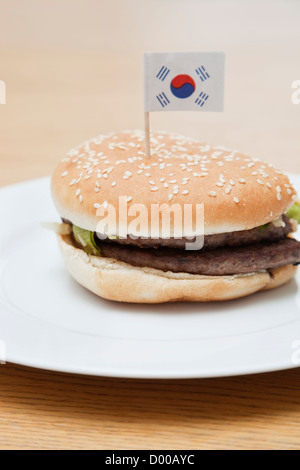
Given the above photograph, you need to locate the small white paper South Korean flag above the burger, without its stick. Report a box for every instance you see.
[144,52,225,112]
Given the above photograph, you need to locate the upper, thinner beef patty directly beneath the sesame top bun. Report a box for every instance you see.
[96,215,293,249]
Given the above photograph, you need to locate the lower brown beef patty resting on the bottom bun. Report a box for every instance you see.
[99,238,300,276]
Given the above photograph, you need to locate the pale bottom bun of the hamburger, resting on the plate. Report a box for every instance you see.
[58,235,297,304]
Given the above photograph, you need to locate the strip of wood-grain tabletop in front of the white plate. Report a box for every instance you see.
[0,365,300,450]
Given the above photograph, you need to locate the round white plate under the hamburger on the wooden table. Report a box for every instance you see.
[0,176,300,378]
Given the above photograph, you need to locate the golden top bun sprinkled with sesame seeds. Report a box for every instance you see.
[52,131,296,237]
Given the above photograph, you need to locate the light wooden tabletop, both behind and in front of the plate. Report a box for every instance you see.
[0,0,300,450]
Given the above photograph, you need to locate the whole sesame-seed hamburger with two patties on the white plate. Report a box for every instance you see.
[52,131,300,303]
